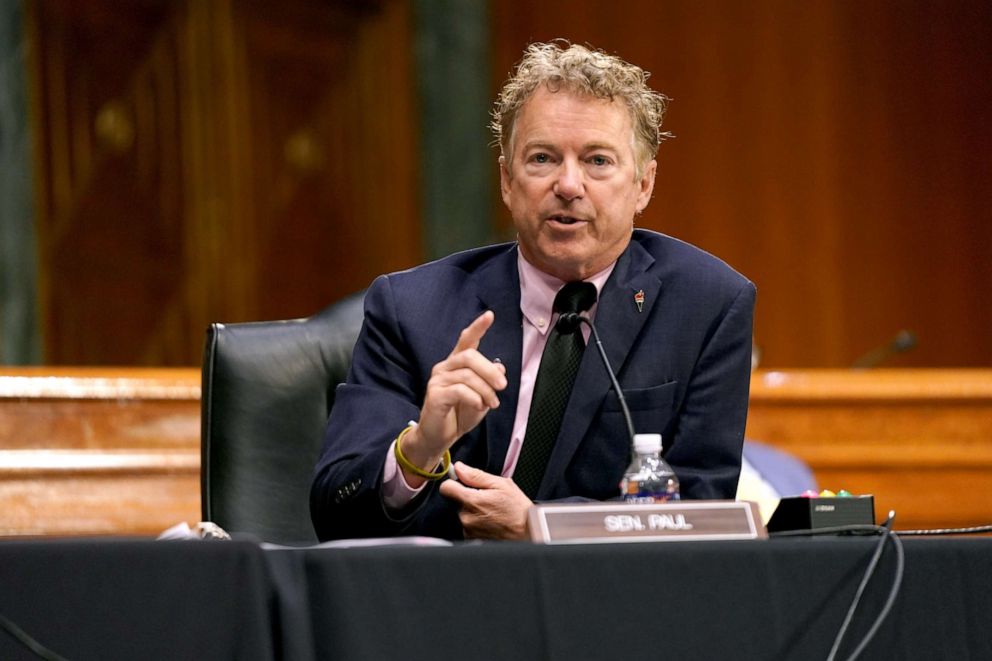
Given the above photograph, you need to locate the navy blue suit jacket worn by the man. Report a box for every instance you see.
[310,230,755,539]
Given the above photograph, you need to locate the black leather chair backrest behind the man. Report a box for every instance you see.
[200,292,364,545]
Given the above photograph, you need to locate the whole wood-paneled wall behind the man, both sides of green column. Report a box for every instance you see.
[27,0,992,367]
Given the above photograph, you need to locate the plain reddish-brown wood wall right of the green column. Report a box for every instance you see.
[492,0,992,367]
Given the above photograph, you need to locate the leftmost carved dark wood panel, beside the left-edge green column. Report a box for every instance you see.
[32,1,183,363]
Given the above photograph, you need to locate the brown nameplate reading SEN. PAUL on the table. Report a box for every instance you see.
[528,500,768,544]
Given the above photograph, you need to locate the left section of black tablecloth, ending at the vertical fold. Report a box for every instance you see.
[0,540,280,661]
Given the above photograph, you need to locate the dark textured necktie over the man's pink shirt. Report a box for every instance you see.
[513,282,596,500]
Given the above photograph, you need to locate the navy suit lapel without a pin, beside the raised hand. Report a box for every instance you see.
[474,247,523,475]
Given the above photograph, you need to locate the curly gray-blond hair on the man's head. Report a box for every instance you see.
[489,40,672,179]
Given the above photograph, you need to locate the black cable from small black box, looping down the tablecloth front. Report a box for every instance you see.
[769,512,905,661]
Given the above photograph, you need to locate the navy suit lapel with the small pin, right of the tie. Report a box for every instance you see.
[540,241,661,498]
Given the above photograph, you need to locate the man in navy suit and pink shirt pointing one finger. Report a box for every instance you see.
[311,43,755,539]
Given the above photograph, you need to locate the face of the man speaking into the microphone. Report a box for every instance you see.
[500,86,657,281]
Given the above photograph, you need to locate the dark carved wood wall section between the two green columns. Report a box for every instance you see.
[27,0,421,365]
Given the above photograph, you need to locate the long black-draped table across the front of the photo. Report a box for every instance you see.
[0,537,992,661]
